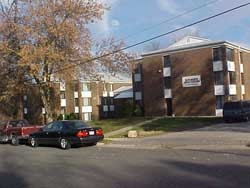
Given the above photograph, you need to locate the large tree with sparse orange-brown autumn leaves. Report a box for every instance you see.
[0,0,135,121]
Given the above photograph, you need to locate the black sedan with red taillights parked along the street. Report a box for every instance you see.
[29,120,104,149]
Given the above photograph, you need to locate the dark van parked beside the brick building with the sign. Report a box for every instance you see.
[223,101,250,122]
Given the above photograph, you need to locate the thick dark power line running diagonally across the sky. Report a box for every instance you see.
[52,2,250,74]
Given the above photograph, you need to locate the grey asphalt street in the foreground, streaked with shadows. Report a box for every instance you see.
[0,144,250,188]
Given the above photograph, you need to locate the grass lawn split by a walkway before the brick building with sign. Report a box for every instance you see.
[90,117,222,137]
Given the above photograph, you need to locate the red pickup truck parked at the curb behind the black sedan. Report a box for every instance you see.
[0,119,42,145]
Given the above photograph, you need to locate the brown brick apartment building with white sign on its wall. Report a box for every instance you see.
[133,36,250,116]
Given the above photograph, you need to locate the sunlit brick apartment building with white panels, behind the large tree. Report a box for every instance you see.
[20,74,132,123]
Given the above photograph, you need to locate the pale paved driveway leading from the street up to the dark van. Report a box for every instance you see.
[105,121,250,150]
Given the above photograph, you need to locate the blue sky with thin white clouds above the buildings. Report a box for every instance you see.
[90,0,250,54]
